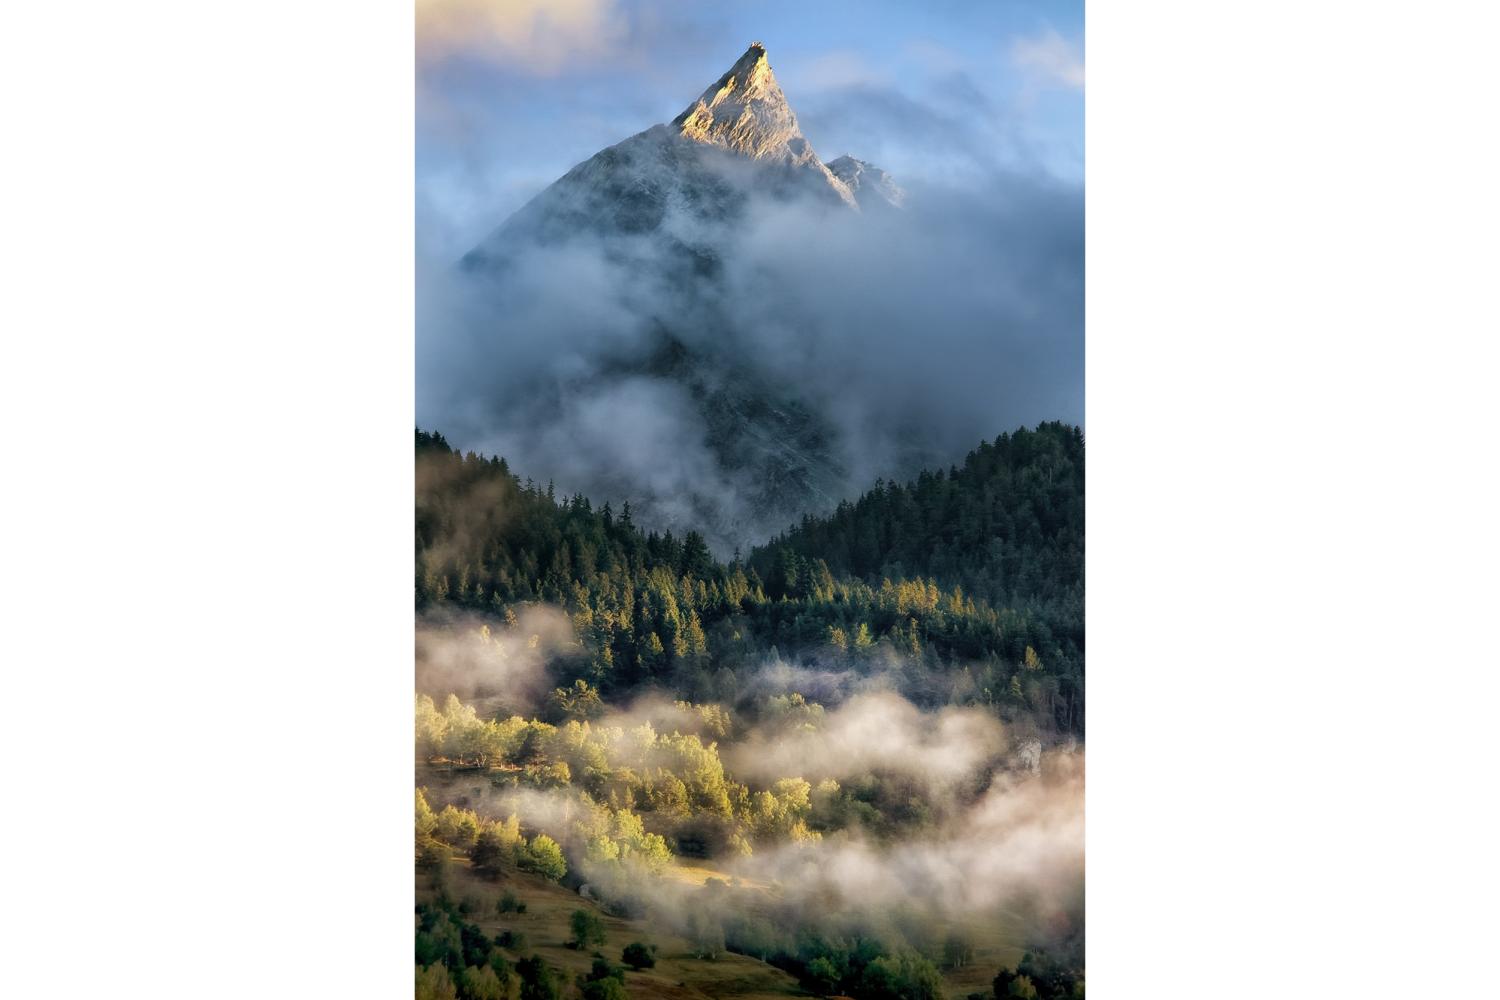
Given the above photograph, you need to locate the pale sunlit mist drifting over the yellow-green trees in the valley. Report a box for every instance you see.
[419,606,1085,934]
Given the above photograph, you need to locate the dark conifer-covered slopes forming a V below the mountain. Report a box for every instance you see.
[416,424,1083,735]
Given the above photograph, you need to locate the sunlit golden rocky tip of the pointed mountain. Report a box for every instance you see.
[672,42,812,162]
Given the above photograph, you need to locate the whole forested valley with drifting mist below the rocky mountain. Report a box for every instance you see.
[414,423,1085,1000]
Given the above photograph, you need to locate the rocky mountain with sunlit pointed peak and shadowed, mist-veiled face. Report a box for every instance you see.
[461,43,900,553]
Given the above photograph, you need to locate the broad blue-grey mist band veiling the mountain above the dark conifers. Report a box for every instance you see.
[417,164,1083,556]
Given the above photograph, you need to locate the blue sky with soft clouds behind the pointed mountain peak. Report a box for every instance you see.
[416,0,1085,258]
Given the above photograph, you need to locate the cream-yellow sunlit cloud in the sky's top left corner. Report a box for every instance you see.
[417,0,623,75]
